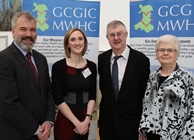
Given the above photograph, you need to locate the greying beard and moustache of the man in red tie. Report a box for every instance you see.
[15,36,36,52]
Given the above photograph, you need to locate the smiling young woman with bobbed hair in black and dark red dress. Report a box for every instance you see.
[52,28,97,140]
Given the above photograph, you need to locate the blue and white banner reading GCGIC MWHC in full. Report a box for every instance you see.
[23,0,100,73]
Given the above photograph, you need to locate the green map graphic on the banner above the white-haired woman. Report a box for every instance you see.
[134,4,154,33]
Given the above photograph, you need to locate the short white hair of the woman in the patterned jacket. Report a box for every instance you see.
[155,34,180,55]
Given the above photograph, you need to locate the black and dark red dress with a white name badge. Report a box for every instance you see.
[52,59,96,140]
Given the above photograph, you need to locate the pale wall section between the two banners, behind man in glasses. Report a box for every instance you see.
[99,0,129,51]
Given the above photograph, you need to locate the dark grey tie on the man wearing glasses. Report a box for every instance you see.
[112,55,122,100]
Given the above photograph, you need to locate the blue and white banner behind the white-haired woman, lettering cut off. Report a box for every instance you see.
[130,0,194,73]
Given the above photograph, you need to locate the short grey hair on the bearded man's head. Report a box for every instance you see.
[11,11,36,29]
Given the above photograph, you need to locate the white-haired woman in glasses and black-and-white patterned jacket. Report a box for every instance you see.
[139,35,194,140]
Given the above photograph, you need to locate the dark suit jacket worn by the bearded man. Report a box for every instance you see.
[0,43,55,140]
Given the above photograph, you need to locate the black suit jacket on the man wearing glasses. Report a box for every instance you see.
[98,46,150,140]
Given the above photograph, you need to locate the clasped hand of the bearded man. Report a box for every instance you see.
[37,122,52,140]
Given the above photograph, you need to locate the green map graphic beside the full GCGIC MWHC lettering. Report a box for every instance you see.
[33,3,49,31]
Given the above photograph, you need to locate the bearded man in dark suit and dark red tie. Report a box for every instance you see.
[0,12,55,140]
